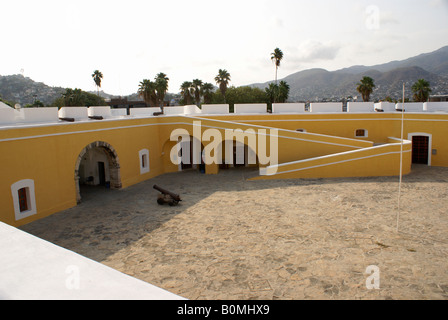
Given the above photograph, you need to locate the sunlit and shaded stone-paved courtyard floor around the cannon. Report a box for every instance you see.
[21,166,448,300]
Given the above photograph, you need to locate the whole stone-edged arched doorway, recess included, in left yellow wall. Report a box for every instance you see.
[75,141,122,203]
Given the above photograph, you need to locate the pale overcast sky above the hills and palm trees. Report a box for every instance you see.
[0,0,448,95]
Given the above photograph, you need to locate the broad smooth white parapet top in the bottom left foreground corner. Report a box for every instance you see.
[0,222,185,300]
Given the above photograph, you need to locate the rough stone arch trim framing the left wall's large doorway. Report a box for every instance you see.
[75,141,122,203]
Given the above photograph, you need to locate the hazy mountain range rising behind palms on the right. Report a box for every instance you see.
[251,46,448,101]
